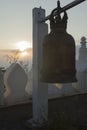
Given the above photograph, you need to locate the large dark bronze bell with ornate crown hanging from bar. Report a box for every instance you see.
[40,2,77,83]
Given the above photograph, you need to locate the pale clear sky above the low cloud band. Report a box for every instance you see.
[0,0,87,49]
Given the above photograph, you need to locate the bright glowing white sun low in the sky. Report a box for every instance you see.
[16,41,31,52]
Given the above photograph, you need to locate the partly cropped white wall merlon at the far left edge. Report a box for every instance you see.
[0,69,5,106]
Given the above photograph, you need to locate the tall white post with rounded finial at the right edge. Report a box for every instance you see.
[76,36,87,93]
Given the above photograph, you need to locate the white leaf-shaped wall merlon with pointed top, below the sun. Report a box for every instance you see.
[4,63,28,105]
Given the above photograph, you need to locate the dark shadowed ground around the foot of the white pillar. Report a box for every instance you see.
[0,94,87,130]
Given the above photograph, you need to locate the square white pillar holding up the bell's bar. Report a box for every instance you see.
[28,8,48,125]
